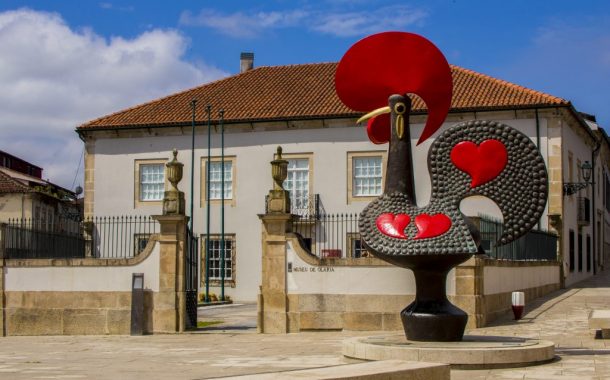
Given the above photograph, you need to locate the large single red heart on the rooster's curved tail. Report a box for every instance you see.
[451,140,508,188]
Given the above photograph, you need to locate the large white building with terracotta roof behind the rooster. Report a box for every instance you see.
[77,57,610,301]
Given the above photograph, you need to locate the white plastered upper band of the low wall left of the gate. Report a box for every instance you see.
[4,242,160,292]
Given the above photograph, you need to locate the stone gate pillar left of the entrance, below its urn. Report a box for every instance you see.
[152,215,188,333]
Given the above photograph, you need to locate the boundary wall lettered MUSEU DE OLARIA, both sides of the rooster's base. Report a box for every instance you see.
[259,211,560,333]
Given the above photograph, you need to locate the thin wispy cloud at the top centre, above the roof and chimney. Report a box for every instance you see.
[180,5,427,38]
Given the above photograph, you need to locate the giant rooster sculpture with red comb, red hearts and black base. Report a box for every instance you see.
[335,32,547,341]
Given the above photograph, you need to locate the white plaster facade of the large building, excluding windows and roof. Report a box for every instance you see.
[94,114,547,301]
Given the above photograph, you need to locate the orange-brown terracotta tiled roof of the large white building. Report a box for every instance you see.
[78,63,569,130]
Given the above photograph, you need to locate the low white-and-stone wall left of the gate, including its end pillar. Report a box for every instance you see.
[0,216,187,336]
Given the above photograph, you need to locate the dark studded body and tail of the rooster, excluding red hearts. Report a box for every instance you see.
[360,117,548,262]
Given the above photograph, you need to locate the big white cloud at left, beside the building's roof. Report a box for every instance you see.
[0,9,227,187]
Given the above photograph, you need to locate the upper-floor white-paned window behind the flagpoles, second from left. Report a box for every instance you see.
[201,156,235,206]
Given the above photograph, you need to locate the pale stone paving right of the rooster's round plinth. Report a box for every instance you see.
[451,270,610,380]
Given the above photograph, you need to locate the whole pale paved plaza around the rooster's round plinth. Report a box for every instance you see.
[0,271,610,380]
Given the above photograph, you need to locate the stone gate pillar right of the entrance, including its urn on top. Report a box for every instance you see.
[258,147,292,334]
